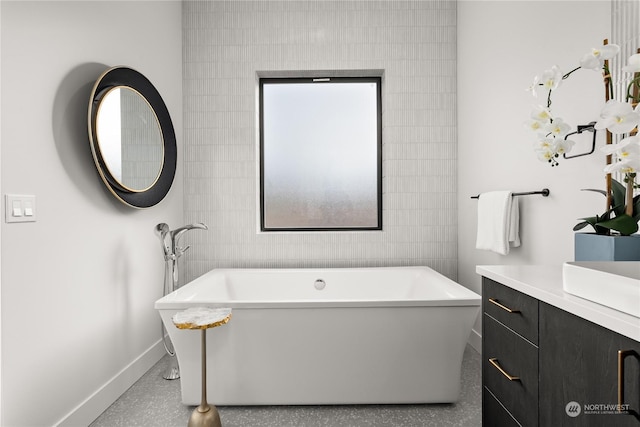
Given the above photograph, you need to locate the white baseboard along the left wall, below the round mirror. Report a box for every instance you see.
[55,340,165,427]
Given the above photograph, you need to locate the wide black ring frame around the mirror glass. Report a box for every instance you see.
[88,66,178,209]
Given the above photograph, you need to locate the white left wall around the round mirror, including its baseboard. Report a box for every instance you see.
[0,1,183,427]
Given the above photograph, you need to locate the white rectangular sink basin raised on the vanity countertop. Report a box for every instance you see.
[562,261,640,317]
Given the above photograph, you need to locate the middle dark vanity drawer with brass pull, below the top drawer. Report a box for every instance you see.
[482,313,538,426]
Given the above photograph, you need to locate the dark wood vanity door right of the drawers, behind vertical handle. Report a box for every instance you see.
[539,302,640,427]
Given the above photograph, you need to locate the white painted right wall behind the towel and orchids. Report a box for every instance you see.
[458,1,611,346]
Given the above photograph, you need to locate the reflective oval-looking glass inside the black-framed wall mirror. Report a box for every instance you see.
[96,86,164,192]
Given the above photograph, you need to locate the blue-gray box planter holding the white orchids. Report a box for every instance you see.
[574,233,640,261]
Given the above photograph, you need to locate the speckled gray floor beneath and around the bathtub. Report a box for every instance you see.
[90,345,482,427]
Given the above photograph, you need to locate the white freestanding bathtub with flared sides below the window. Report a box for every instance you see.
[155,267,481,406]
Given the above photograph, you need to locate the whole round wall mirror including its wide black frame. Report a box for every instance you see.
[88,67,177,208]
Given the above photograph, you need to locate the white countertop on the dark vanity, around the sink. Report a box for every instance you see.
[476,265,640,342]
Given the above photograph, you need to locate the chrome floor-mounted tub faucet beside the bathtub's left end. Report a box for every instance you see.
[155,222,208,380]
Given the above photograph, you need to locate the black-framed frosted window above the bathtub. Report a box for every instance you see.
[260,77,382,231]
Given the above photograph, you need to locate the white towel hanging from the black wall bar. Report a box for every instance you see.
[476,191,520,255]
